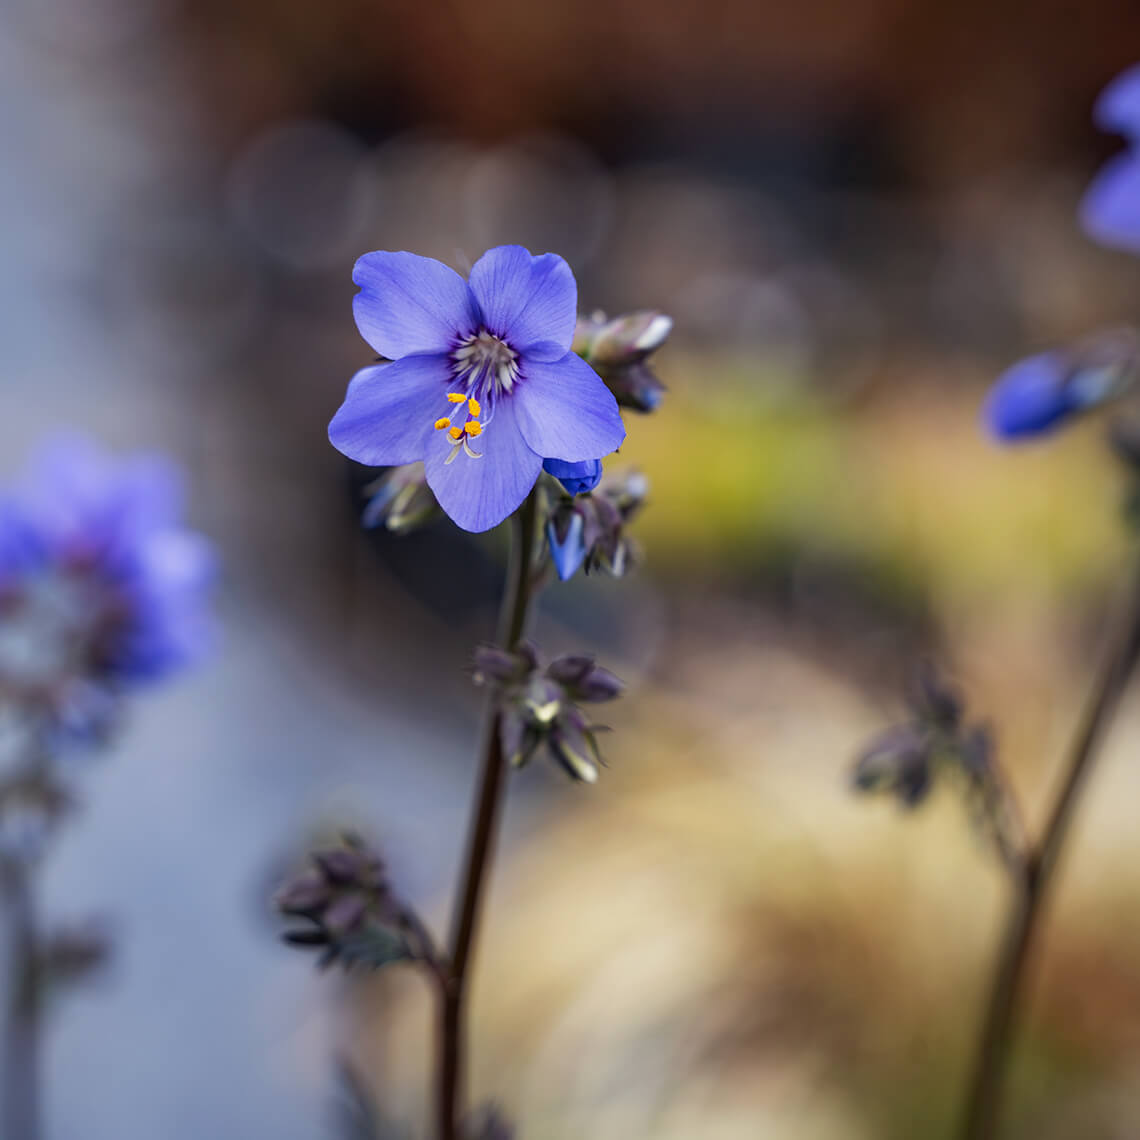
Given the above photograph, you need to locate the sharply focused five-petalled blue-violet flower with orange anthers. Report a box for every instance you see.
[328,245,626,531]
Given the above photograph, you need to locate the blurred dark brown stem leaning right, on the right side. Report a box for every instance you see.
[960,567,1140,1140]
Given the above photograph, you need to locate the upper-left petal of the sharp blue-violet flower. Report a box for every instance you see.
[352,251,479,360]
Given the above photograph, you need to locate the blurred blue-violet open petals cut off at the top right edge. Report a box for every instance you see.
[1081,65,1140,253]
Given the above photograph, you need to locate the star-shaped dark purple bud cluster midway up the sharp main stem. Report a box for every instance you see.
[474,643,622,783]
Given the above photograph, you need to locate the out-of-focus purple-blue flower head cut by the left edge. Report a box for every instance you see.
[0,437,215,693]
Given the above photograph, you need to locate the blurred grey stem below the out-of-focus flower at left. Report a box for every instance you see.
[0,860,41,1140]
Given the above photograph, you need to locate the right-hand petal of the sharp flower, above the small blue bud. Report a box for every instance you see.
[511,352,626,462]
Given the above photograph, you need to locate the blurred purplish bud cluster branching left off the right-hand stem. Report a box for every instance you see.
[854,667,1024,863]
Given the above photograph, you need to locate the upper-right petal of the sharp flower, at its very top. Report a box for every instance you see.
[471,245,578,360]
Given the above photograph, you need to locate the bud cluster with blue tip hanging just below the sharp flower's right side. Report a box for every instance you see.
[546,471,649,581]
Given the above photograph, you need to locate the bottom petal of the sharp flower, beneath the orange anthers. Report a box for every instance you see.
[424,400,543,531]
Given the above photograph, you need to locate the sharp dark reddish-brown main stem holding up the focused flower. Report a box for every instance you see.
[437,488,538,1140]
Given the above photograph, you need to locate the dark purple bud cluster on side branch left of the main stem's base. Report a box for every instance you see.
[276,834,434,969]
